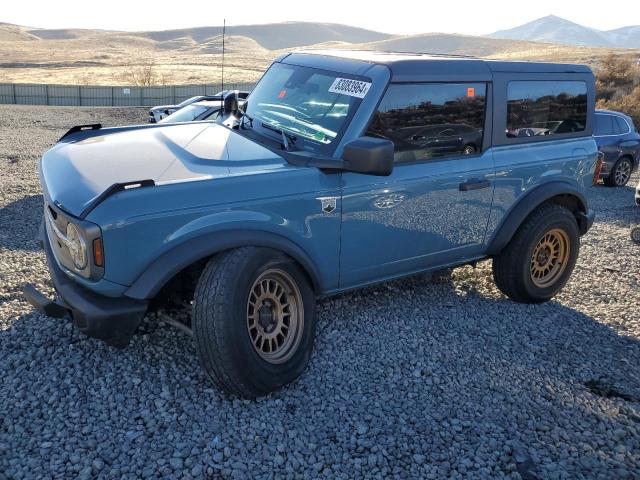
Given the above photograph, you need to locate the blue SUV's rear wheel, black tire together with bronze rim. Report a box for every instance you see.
[493,204,580,303]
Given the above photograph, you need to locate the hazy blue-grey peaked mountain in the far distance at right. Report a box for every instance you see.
[487,15,640,48]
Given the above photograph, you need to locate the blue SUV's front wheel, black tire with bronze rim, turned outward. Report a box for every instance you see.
[193,247,315,398]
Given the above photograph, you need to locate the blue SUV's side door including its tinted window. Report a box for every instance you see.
[340,83,494,288]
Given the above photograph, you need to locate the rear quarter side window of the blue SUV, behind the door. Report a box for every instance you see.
[506,81,587,138]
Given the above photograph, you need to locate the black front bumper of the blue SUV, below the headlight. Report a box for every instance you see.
[23,223,148,347]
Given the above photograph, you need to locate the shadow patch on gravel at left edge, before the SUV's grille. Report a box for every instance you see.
[0,195,44,252]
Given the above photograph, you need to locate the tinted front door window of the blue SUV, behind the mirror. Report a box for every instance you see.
[366,83,487,162]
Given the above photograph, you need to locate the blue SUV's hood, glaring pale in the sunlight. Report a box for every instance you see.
[40,122,285,216]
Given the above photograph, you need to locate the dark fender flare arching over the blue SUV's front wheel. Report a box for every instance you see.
[125,230,322,300]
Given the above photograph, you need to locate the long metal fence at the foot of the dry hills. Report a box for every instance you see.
[0,83,254,107]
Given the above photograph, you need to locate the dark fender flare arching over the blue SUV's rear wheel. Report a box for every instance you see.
[487,181,593,256]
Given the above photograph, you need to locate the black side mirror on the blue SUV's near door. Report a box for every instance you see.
[342,137,394,177]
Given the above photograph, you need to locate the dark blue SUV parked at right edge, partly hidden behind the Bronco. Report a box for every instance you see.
[593,110,640,187]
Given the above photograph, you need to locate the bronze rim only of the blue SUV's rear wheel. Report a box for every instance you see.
[530,228,571,288]
